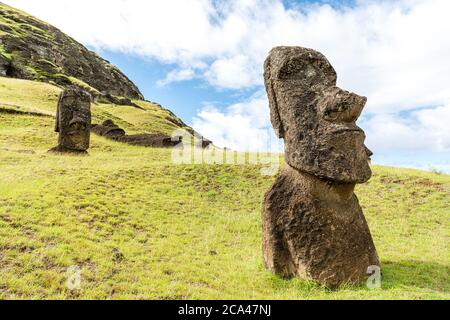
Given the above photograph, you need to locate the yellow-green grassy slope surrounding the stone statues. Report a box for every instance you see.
[0,78,450,299]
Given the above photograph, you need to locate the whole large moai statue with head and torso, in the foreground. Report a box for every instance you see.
[263,47,380,288]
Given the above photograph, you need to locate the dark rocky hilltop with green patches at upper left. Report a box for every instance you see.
[0,2,143,99]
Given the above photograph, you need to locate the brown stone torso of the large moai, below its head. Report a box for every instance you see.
[263,165,379,288]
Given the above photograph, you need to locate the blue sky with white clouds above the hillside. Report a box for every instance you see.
[2,0,450,173]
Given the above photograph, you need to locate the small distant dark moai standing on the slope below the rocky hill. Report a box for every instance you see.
[50,86,91,154]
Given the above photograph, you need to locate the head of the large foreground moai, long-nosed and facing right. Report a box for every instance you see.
[264,47,372,183]
